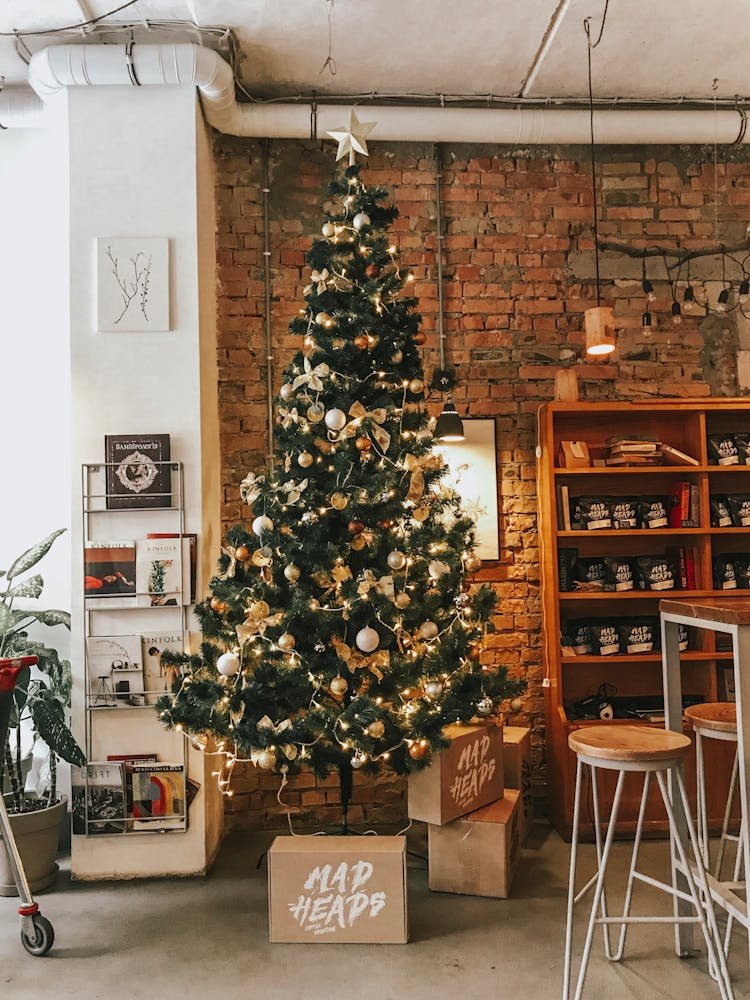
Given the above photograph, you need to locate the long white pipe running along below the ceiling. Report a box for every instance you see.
[0,43,750,145]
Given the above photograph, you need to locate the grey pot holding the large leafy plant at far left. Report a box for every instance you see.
[0,799,67,896]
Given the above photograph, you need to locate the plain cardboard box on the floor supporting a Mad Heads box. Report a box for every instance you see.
[428,788,521,899]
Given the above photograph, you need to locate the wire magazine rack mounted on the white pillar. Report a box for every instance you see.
[79,461,189,839]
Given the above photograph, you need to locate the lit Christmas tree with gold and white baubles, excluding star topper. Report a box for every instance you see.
[158,137,523,828]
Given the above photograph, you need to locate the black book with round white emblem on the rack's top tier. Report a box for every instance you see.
[104,434,172,510]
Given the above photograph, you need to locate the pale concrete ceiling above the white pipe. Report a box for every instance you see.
[0,0,750,101]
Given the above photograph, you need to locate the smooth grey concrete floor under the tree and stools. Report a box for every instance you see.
[0,825,750,1000]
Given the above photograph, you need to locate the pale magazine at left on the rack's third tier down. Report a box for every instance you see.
[86,635,145,708]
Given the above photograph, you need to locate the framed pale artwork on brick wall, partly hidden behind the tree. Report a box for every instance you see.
[436,417,500,560]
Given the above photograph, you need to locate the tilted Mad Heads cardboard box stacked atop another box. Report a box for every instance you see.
[409,722,504,826]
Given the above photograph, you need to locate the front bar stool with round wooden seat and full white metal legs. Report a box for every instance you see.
[563,725,734,1000]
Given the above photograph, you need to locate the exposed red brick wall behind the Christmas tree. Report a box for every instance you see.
[215,136,750,827]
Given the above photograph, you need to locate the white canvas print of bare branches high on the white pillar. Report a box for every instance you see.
[96,237,169,332]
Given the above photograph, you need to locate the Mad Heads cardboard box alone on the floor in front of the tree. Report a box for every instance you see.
[268,836,408,944]
